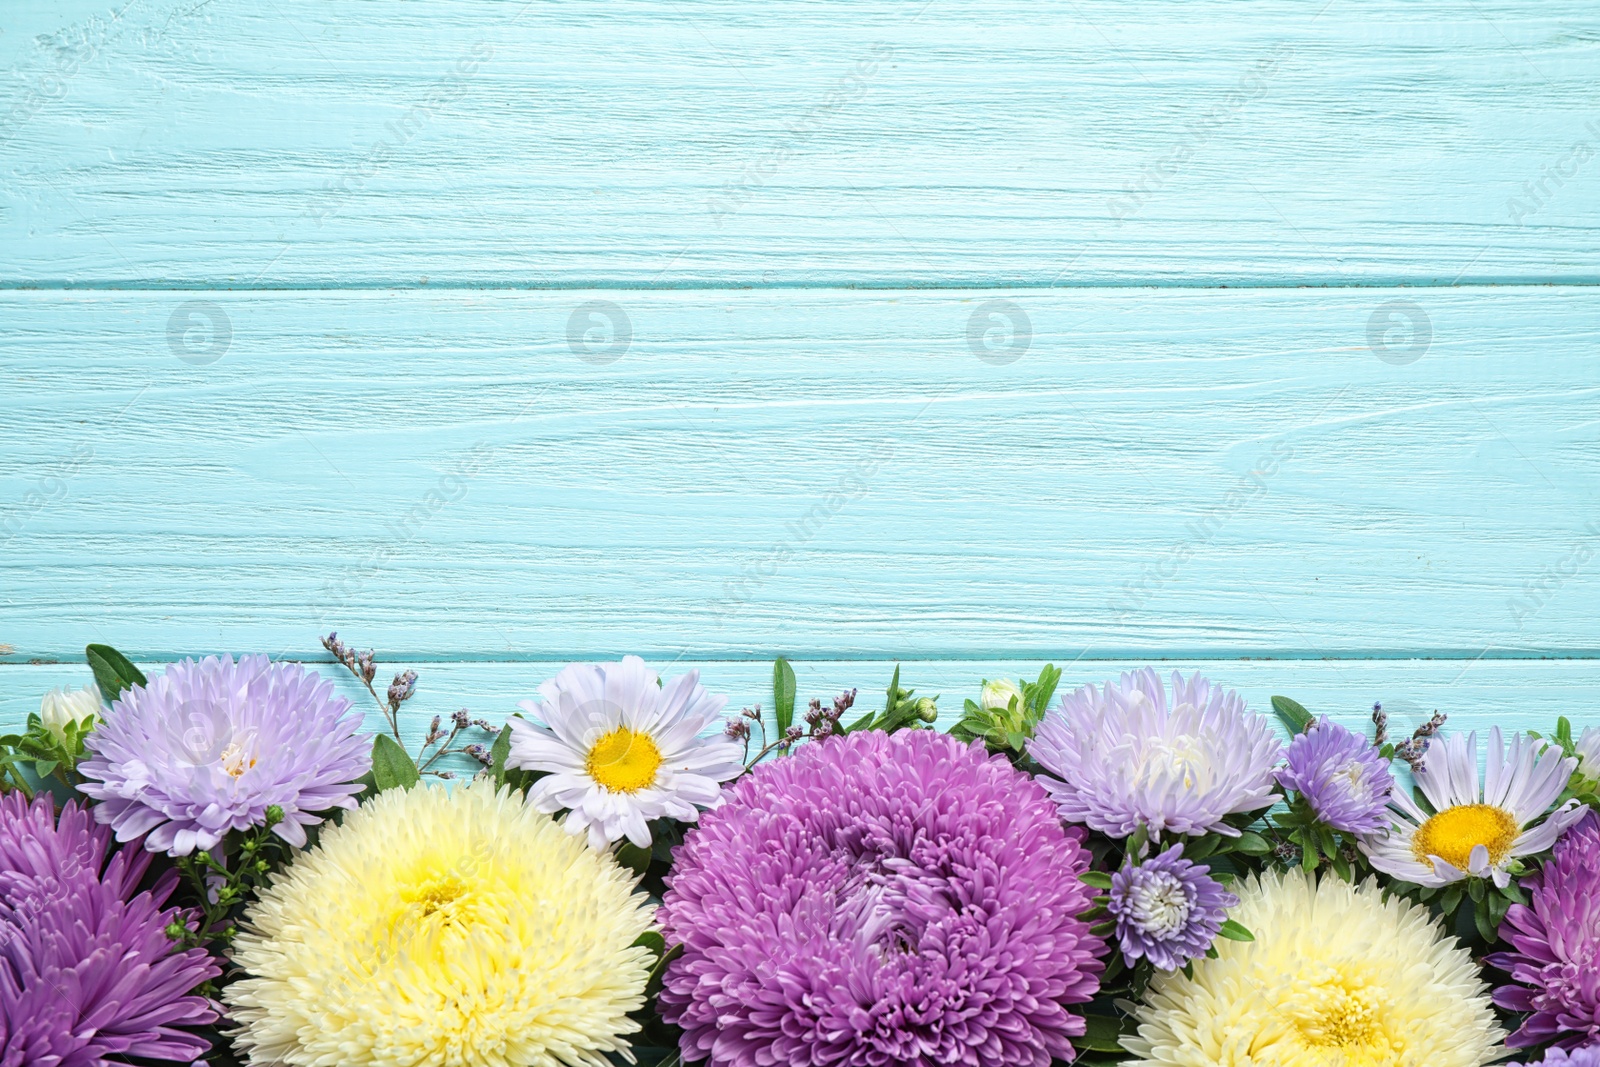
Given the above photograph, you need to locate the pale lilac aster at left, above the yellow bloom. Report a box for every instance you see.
[78,656,371,856]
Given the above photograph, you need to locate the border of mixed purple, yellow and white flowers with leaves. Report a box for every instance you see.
[0,633,1600,1067]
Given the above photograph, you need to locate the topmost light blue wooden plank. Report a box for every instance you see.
[0,0,1600,288]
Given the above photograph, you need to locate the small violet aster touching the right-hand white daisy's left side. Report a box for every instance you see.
[1278,715,1395,833]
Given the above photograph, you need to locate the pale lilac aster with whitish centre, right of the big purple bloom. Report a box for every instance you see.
[1027,667,1282,838]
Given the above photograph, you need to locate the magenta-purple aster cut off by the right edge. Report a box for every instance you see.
[1485,813,1600,1048]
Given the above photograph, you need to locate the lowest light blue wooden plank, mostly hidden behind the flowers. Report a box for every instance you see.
[0,656,1600,734]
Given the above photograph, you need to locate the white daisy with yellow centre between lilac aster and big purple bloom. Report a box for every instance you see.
[506,656,744,848]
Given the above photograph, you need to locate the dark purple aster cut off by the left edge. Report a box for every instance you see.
[0,793,221,1067]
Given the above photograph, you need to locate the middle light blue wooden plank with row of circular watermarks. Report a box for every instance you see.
[0,288,1600,661]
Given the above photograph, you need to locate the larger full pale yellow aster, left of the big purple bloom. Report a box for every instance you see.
[222,781,653,1067]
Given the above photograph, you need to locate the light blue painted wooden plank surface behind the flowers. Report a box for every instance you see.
[0,0,1600,742]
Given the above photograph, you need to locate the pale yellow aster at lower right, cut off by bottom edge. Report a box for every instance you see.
[1122,870,1502,1067]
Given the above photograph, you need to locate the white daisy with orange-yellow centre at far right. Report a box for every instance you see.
[1360,726,1584,888]
